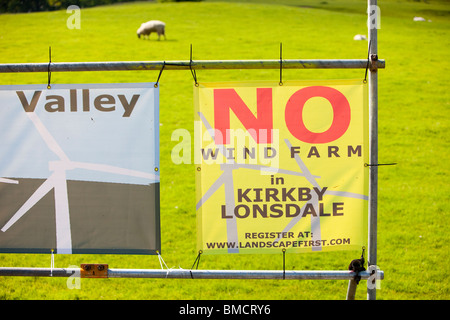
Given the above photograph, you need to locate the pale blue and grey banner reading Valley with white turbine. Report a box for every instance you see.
[0,83,160,254]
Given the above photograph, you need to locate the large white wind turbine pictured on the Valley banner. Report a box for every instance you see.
[0,112,159,254]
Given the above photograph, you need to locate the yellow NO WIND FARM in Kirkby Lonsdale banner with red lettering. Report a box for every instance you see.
[194,80,369,254]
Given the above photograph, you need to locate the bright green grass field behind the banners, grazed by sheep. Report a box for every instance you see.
[0,0,450,300]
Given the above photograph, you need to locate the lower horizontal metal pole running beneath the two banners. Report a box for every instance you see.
[0,267,384,280]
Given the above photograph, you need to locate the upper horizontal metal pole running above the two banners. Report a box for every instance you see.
[0,59,385,73]
